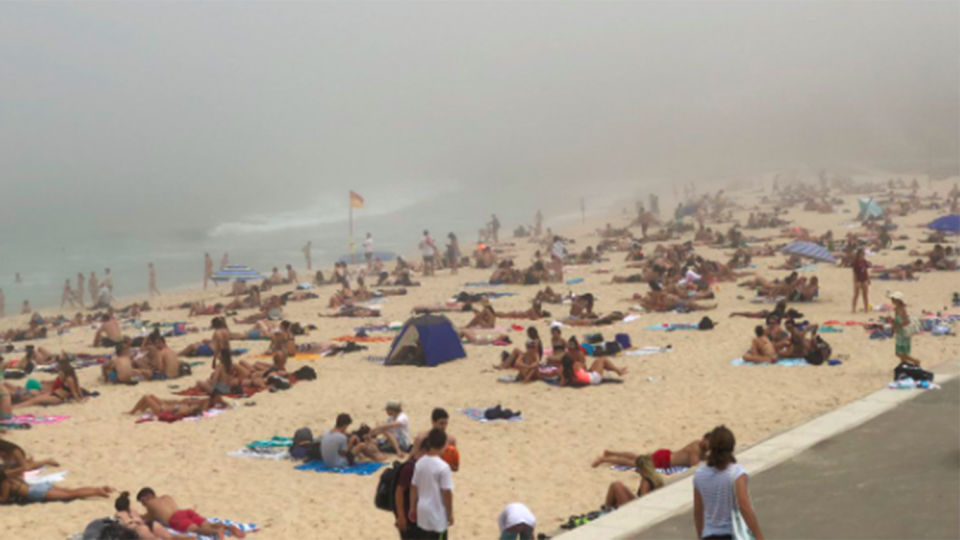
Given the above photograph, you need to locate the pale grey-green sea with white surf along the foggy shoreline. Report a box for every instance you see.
[0,185,632,316]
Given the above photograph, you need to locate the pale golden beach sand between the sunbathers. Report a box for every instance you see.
[0,179,960,540]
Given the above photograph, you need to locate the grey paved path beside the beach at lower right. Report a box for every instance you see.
[630,378,960,540]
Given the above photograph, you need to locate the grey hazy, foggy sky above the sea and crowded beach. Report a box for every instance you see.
[0,0,960,236]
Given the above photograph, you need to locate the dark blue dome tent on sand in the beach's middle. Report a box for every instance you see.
[384,315,467,367]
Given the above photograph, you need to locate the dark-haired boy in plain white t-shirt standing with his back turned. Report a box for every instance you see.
[410,429,453,540]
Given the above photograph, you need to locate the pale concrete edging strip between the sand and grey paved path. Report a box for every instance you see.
[560,361,960,540]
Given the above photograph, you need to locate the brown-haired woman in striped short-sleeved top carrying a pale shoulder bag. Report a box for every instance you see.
[693,426,763,540]
